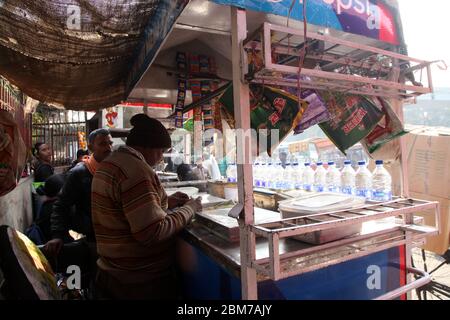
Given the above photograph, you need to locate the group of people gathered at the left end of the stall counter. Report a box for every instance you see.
[27,114,202,299]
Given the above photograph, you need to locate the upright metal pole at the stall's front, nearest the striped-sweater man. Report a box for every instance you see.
[231,7,258,300]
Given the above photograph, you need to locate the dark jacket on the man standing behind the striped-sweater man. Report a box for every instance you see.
[51,162,95,241]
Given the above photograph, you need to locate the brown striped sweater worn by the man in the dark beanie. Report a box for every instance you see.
[92,146,196,292]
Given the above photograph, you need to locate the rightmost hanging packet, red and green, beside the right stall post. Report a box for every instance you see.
[361,98,408,154]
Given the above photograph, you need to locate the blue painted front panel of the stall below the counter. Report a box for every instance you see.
[179,242,400,300]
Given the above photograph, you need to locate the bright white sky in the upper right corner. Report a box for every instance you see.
[398,0,450,88]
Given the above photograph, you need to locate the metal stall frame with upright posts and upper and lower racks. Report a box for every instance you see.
[229,7,440,300]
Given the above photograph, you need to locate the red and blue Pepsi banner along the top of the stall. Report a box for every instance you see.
[212,0,403,45]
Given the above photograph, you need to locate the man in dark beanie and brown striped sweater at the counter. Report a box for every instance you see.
[92,114,201,299]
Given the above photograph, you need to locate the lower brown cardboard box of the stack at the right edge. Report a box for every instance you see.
[410,192,450,254]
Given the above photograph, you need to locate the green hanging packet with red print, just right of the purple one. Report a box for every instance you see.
[319,92,384,154]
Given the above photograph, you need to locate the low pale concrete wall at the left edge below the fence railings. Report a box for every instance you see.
[0,176,33,232]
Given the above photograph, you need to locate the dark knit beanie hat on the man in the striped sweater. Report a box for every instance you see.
[127,113,172,149]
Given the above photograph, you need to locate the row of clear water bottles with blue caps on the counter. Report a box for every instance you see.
[227,160,392,201]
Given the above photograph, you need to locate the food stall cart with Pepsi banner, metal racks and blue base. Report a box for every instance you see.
[121,0,439,299]
